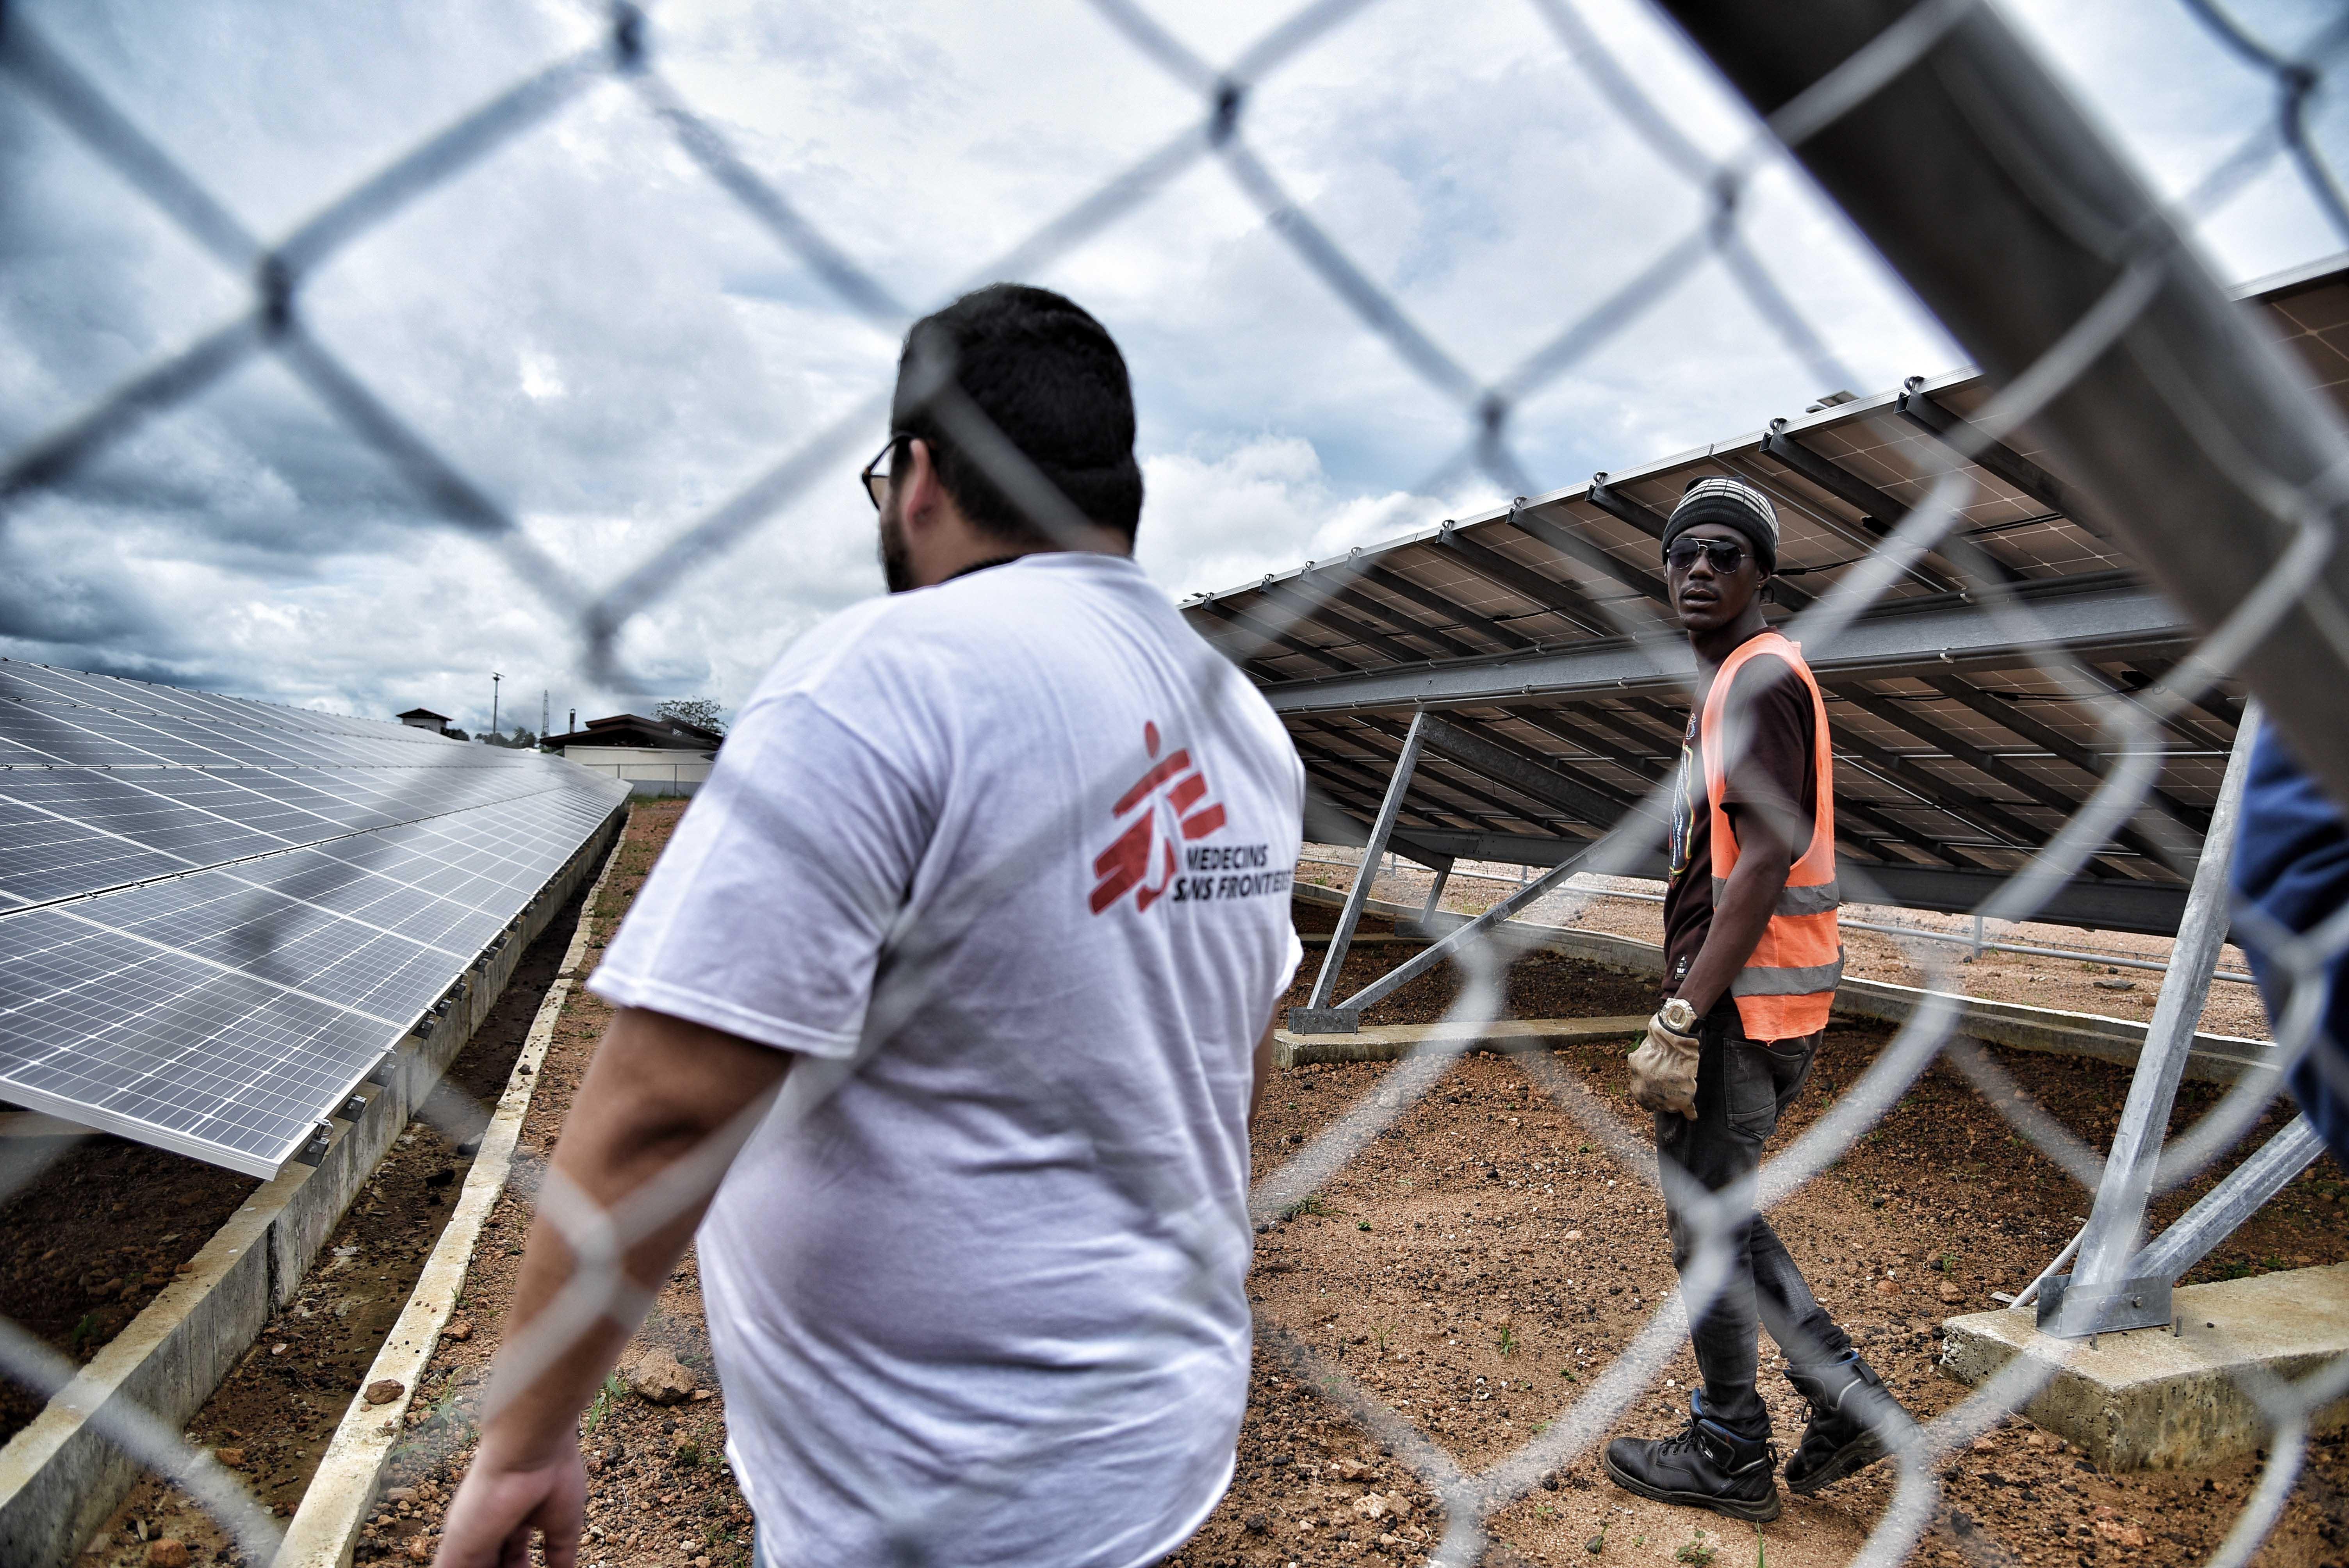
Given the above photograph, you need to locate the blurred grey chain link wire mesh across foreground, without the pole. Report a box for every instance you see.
[0,0,2349,1566]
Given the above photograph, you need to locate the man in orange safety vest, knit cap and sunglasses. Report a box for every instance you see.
[1607,476,1900,1521]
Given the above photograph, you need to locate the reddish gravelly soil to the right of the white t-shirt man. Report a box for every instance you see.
[1177,906,2349,1566]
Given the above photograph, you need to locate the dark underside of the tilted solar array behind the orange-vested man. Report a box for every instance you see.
[1184,248,2349,930]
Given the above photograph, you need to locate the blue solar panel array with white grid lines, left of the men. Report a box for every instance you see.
[0,659,627,1176]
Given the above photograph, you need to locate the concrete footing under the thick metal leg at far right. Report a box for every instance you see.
[1940,1263,2349,1469]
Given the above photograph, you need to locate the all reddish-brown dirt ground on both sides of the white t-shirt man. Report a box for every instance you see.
[78,805,2349,1568]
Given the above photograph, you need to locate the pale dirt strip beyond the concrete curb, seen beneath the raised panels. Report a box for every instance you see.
[1297,845,2269,1040]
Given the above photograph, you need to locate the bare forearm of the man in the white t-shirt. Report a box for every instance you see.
[484,1009,789,1465]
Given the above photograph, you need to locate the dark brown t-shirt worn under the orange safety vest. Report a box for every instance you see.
[1663,634,1818,1021]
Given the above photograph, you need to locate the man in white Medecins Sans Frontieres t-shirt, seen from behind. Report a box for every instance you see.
[439,284,1304,1568]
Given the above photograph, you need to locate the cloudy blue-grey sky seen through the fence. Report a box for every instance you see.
[0,0,2349,728]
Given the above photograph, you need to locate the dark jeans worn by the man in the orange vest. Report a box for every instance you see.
[1656,1014,1851,1436]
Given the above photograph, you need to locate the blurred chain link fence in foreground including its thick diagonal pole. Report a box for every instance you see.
[0,0,2349,1566]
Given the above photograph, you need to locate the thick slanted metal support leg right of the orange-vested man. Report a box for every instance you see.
[2039,702,2260,1338]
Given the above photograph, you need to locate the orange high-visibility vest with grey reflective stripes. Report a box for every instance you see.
[1696,631,1844,1040]
